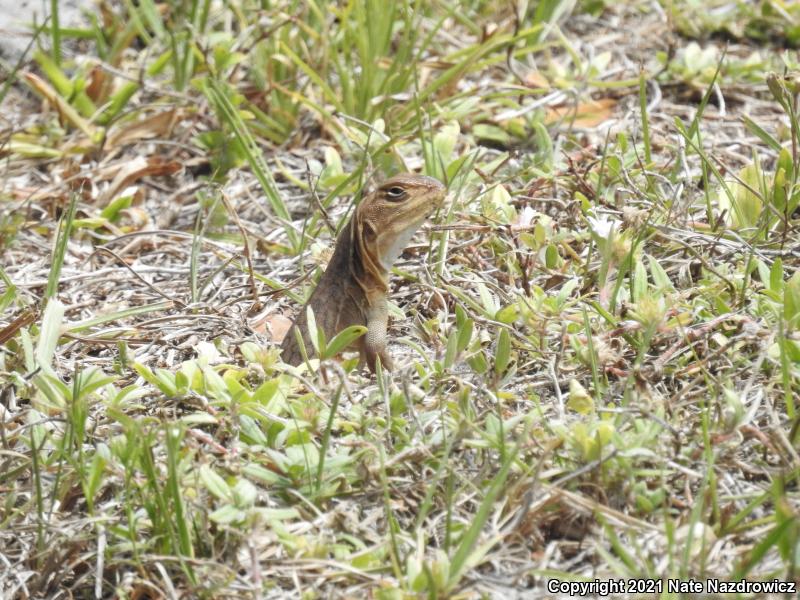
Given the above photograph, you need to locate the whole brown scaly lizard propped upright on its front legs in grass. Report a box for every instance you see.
[281,173,446,373]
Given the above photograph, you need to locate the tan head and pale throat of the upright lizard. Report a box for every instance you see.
[354,173,447,279]
